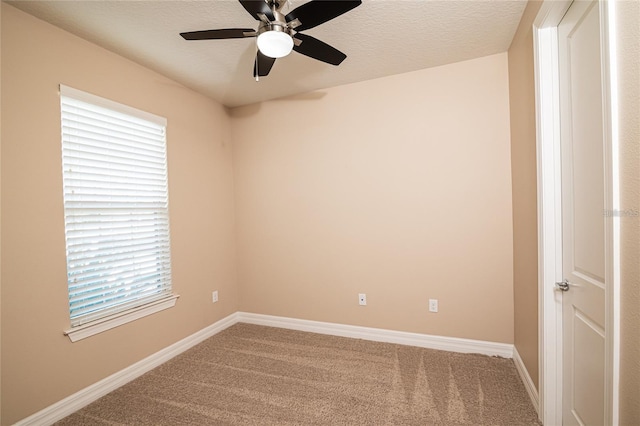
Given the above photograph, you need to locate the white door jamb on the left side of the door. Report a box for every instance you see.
[533,1,571,425]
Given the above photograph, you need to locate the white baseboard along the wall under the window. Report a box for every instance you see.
[15,313,238,426]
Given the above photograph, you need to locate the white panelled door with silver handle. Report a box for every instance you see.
[558,1,610,425]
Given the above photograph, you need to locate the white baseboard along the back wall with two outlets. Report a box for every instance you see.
[238,312,513,358]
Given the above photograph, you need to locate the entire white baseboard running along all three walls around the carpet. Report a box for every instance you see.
[15,312,516,426]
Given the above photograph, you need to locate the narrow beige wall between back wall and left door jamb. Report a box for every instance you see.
[508,1,542,388]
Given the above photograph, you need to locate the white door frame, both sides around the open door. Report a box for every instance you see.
[533,0,620,425]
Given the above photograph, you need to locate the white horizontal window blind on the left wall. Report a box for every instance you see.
[60,86,171,327]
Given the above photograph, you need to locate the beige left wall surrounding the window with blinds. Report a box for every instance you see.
[1,3,238,424]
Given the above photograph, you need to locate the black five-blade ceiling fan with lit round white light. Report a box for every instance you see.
[180,0,362,80]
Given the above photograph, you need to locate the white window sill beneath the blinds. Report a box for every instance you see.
[64,294,180,342]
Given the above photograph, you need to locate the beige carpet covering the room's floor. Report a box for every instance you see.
[58,324,539,426]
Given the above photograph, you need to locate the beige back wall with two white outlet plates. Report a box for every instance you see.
[232,53,513,343]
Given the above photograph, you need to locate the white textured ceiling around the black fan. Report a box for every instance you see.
[7,0,526,107]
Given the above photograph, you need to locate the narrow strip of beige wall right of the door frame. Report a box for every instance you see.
[616,1,640,425]
